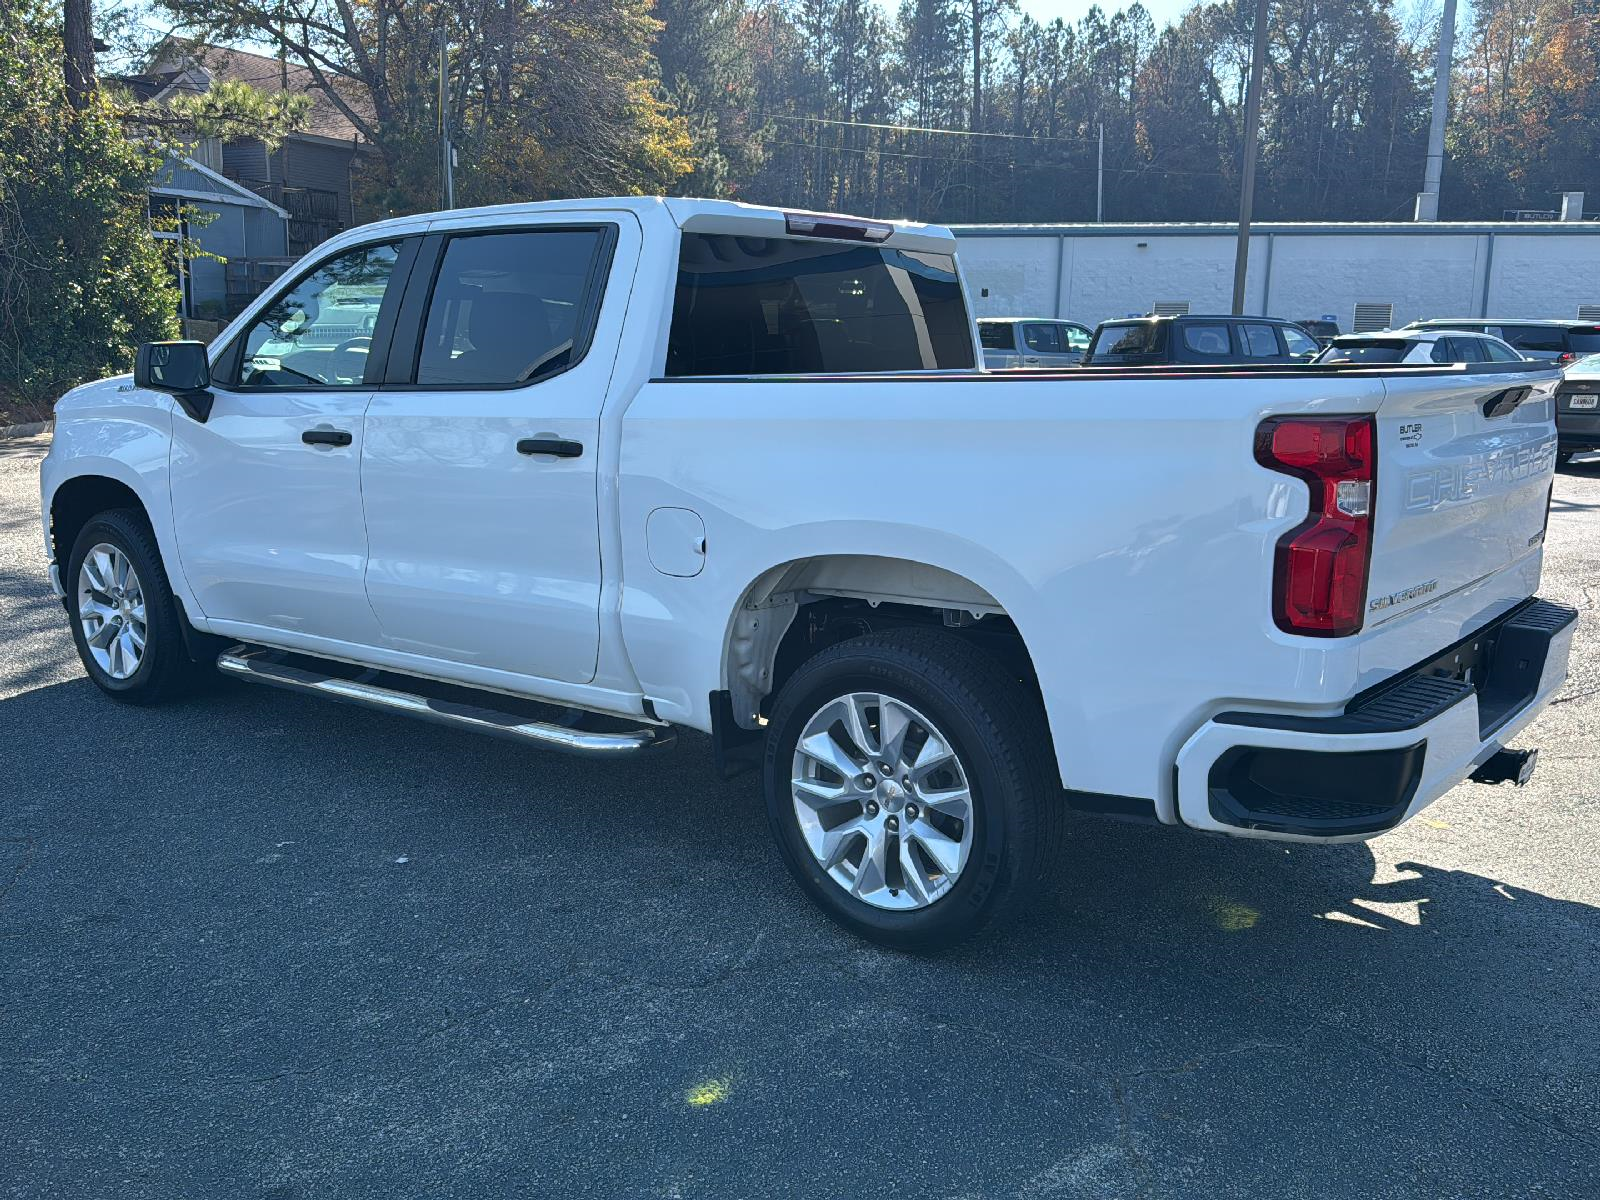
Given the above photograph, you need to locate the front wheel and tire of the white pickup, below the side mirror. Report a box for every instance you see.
[62,509,206,704]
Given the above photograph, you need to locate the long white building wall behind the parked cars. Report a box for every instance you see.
[955,222,1600,330]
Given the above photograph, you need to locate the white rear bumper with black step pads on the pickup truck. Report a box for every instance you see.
[1178,600,1578,842]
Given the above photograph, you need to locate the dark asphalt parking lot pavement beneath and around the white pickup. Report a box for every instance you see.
[0,438,1600,1200]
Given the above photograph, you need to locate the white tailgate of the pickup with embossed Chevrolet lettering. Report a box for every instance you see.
[1366,368,1562,627]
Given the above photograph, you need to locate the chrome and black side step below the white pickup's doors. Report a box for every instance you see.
[216,646,677,758]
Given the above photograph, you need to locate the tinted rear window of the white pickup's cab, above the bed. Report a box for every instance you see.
[667,234,973,376]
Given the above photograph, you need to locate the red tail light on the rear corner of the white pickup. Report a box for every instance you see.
[1256,416,1378,637]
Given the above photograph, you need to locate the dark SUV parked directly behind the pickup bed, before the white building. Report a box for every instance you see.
[1083,315,1318,366]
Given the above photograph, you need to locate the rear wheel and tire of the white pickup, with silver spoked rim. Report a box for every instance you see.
[765,629,1061,952]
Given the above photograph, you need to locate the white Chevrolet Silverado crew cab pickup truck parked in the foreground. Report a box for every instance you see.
[42,198,1576,947]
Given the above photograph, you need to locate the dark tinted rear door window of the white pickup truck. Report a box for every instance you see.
[416,229,605,387]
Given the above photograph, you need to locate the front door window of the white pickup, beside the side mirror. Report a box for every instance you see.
[234,242,400,389]
